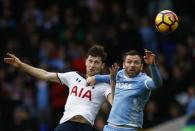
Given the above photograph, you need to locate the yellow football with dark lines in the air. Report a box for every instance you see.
[155,10,179,32]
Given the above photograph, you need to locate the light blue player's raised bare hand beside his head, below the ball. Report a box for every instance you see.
[144,49,155,65]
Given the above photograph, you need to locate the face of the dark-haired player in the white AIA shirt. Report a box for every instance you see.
[85,55,104,76]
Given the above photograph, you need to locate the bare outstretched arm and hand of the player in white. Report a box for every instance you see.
[4,53,60,83]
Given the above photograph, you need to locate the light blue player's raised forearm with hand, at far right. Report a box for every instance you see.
[144,49,162,87]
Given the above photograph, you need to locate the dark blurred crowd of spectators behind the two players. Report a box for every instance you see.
[0,0,195,131]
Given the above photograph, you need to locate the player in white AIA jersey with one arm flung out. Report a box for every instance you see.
[4,45,113,131]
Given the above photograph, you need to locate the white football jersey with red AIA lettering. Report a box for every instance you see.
[57,72,111,125]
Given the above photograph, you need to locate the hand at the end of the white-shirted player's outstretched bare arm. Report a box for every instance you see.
[4,53,22,68]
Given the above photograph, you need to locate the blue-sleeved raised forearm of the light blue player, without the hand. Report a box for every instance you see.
[149,64,163,87]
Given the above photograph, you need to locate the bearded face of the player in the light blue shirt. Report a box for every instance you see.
[123,55,143,77]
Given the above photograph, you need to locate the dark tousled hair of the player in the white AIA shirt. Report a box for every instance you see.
[86,45,107,63]
